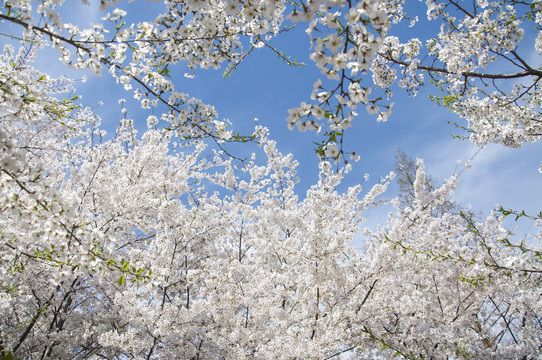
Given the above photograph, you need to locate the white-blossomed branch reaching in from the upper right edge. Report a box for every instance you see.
[372,1,542,155]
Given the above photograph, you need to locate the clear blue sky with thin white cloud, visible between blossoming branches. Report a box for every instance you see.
[5,0,542,239]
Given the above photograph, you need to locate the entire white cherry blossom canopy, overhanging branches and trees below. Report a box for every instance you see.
[0,0,542,359]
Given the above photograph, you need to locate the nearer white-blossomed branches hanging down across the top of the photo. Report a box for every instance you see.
[6,0,542,158]
